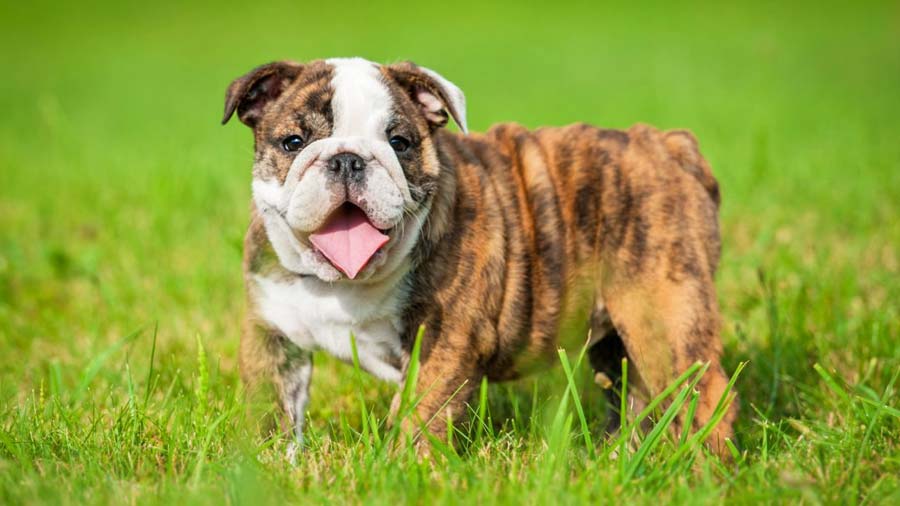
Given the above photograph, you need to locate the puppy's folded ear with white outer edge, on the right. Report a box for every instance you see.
[384,62,469,133]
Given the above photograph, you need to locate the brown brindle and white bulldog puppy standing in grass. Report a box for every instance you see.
[223,58,736,452]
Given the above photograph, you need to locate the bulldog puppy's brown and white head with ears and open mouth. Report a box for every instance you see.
[222,58,466,281]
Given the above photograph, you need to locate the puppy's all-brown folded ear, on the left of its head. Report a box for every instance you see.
[222,61,303,128]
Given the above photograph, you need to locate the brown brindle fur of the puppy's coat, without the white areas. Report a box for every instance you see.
[229,62,737,453]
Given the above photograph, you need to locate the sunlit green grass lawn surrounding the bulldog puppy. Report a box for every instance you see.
[0,2,900,504]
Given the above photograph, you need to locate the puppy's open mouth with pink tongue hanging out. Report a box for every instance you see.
[309,204,389,279]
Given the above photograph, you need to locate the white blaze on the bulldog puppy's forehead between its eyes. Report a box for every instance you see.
[326,58,393,139]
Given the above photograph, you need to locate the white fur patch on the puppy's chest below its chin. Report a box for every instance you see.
[250,275,405,383]
